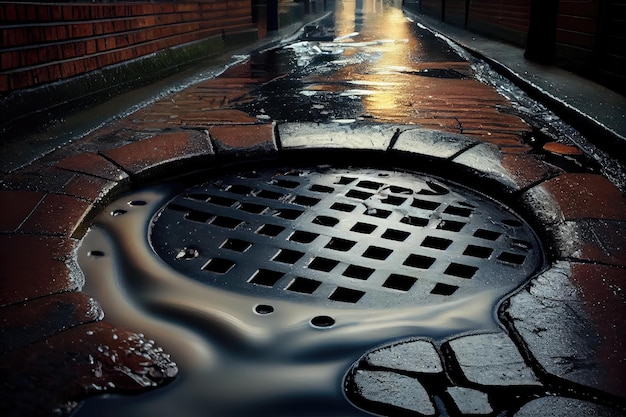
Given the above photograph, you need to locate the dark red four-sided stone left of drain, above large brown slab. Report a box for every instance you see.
[18,194,92,236]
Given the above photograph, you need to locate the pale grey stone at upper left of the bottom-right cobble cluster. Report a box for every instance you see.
[364,340,443,374]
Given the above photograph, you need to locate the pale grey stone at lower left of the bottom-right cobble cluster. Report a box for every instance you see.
[354,370,435,416]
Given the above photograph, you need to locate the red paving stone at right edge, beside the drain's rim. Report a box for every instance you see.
[542,173,626,220]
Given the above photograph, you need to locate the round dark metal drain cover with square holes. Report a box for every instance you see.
[150,167,542,308]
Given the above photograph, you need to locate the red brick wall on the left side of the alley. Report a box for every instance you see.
[0,0,254,95]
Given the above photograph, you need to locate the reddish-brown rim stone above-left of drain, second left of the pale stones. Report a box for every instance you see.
[102,131,213,174]
